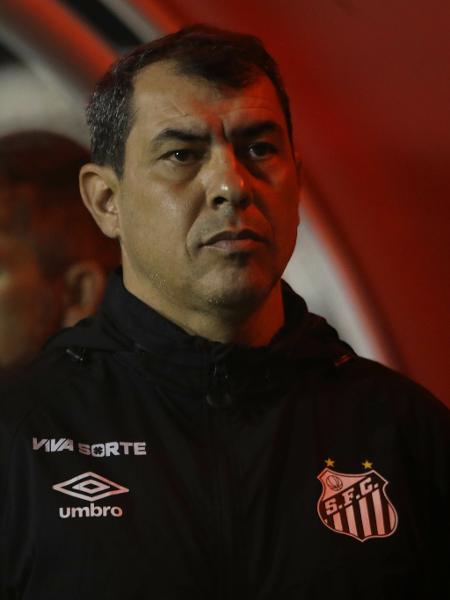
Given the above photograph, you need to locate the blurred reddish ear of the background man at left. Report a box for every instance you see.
[61,260,106,327]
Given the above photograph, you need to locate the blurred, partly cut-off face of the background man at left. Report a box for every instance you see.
[0,230,56,369]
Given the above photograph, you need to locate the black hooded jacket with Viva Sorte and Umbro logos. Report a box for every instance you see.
[0,275,449,600]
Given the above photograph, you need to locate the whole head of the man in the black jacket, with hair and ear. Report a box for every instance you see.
[81,26,298,340]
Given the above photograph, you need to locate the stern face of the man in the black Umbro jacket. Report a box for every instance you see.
[117,62,298,318]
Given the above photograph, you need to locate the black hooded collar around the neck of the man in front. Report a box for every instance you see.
[49,270,353,405]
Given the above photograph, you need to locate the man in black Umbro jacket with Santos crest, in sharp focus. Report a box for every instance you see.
[0,26,448,600]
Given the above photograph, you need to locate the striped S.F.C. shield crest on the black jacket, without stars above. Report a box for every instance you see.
[317,468,398,542]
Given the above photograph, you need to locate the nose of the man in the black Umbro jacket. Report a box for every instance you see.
[206,147,251,208]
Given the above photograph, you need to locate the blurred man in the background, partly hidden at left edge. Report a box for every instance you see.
[0,131,118,373]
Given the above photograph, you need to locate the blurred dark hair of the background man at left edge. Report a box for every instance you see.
[0,130,120,278]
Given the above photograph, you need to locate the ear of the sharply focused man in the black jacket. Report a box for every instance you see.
[80,163,120,238]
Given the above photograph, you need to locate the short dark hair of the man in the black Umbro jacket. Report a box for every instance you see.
[87,24,292,177]
